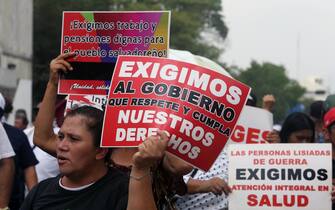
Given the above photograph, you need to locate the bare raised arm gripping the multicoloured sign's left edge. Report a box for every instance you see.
[34,53,74,156]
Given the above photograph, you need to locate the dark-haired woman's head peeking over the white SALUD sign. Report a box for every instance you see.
[279,112,315,143]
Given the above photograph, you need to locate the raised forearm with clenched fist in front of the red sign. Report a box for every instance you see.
[127,131,168,210]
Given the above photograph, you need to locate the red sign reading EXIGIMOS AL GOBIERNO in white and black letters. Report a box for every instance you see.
[101,56,250,170]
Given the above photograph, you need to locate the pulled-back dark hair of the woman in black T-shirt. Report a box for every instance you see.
[65,106,104,147]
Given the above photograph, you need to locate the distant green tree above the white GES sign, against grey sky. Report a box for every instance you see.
[237,61,305,122]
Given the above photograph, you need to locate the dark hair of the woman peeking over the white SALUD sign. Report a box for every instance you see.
[279,112,315,143]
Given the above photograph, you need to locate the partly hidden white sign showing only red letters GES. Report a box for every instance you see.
[228,106,273,144]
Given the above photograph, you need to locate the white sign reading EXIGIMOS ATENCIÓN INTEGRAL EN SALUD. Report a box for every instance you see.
[228,144,332,210]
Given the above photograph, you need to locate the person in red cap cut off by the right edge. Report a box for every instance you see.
[323,108,335,210]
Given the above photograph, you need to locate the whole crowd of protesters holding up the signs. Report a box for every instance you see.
[0,53,335,210]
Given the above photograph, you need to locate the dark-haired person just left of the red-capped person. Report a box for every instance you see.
[309,101,326,143]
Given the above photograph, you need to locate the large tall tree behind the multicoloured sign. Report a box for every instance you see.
[33,0,228,104]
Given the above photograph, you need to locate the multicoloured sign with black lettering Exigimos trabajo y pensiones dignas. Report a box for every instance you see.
[58,11,170,95]
